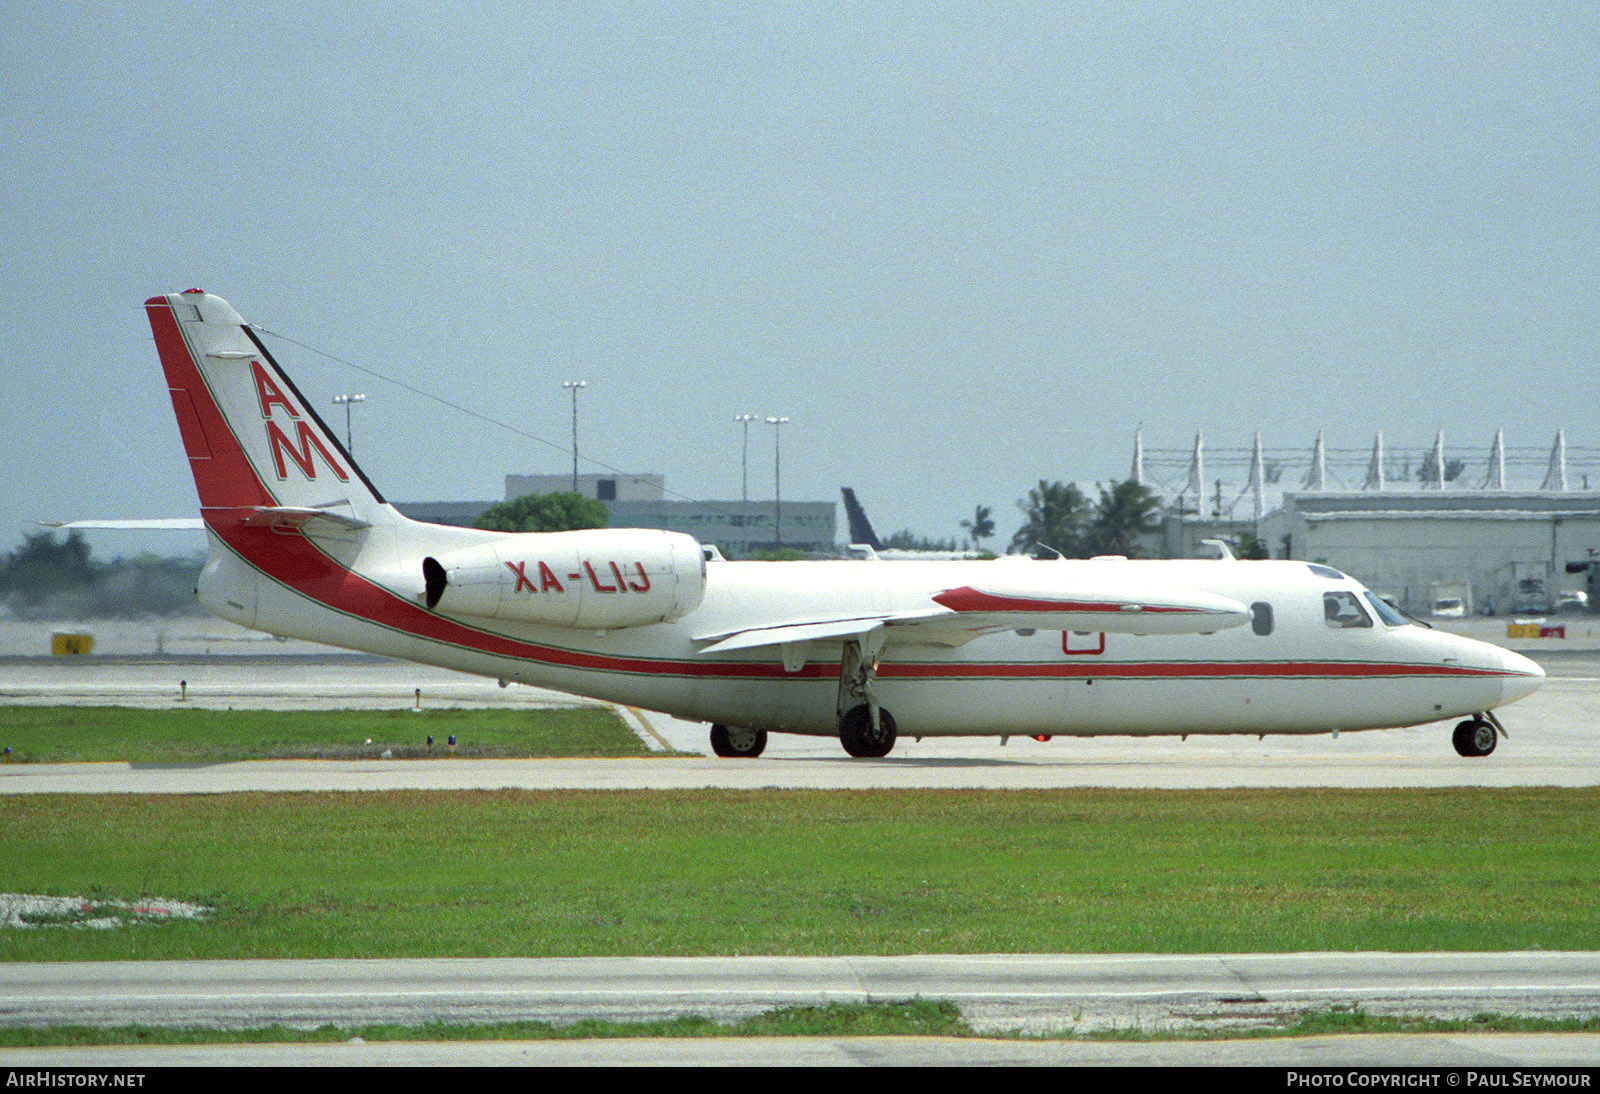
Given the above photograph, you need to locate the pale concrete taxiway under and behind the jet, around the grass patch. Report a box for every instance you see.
[0,643,1600,793]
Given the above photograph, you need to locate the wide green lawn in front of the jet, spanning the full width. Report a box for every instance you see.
[0,789,1600,961]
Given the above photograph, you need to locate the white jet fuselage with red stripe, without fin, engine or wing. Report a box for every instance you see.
[202,526,1542,736]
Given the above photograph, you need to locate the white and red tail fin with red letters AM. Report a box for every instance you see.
[144,289,398,528]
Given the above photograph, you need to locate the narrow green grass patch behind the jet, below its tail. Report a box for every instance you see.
[0,707,650,763]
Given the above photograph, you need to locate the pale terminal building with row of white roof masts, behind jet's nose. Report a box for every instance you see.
[1134,433,1600,616]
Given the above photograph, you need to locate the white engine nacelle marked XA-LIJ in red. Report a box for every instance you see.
[422,528,706,630]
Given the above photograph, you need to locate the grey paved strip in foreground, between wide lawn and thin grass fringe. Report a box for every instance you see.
[0,952,1600,1033]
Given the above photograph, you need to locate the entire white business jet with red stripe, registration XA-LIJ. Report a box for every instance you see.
[146,289,1544,757]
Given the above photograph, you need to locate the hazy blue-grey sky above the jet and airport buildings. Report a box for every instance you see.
[0,0,1600,553]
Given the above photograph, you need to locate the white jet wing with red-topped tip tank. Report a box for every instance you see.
[696,581,1250,654]
